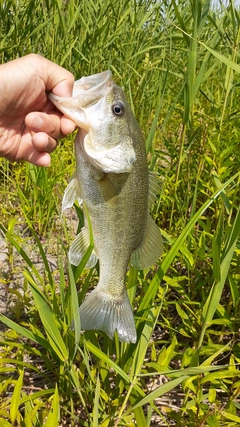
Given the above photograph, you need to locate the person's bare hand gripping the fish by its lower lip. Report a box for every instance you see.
[0,54,76,166]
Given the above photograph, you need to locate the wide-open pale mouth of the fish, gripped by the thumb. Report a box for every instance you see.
[49,70,113,131]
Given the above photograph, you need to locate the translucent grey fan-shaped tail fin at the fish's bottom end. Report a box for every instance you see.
[79,288,137,343]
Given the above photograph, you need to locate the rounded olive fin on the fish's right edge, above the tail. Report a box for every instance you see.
[130,215,163,270]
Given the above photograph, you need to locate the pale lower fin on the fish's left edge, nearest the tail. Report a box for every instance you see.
[68,227,98,268]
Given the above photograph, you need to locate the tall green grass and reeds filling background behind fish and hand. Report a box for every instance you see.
[0,0,240,427]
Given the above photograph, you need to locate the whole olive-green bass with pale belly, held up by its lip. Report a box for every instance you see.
[50,70,163,343]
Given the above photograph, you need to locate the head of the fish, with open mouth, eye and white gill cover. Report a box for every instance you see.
[50,71,140,173]
